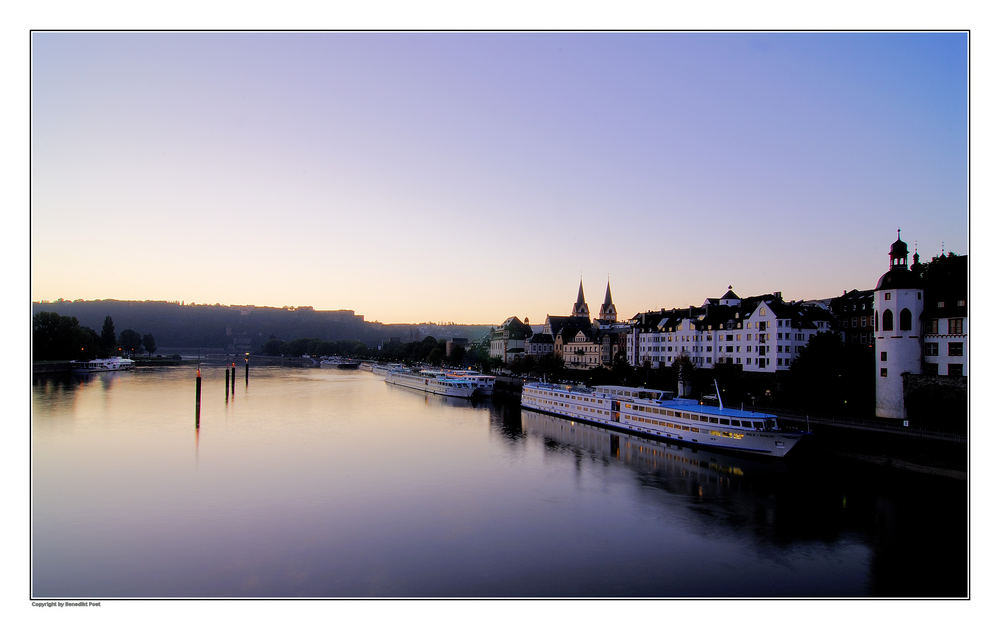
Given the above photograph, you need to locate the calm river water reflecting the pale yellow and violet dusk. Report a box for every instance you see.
[31,367,967,598]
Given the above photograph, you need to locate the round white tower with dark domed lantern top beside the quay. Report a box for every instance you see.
[875,231,924,419]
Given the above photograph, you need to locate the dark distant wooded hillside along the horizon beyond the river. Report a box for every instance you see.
[31,300,490,352]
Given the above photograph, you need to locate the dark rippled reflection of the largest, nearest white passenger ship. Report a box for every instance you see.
[521,409,787,494]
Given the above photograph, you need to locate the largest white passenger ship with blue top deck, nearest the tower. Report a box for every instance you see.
[521,383,804,457]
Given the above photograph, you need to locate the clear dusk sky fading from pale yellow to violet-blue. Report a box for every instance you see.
[30,32,969,323]
